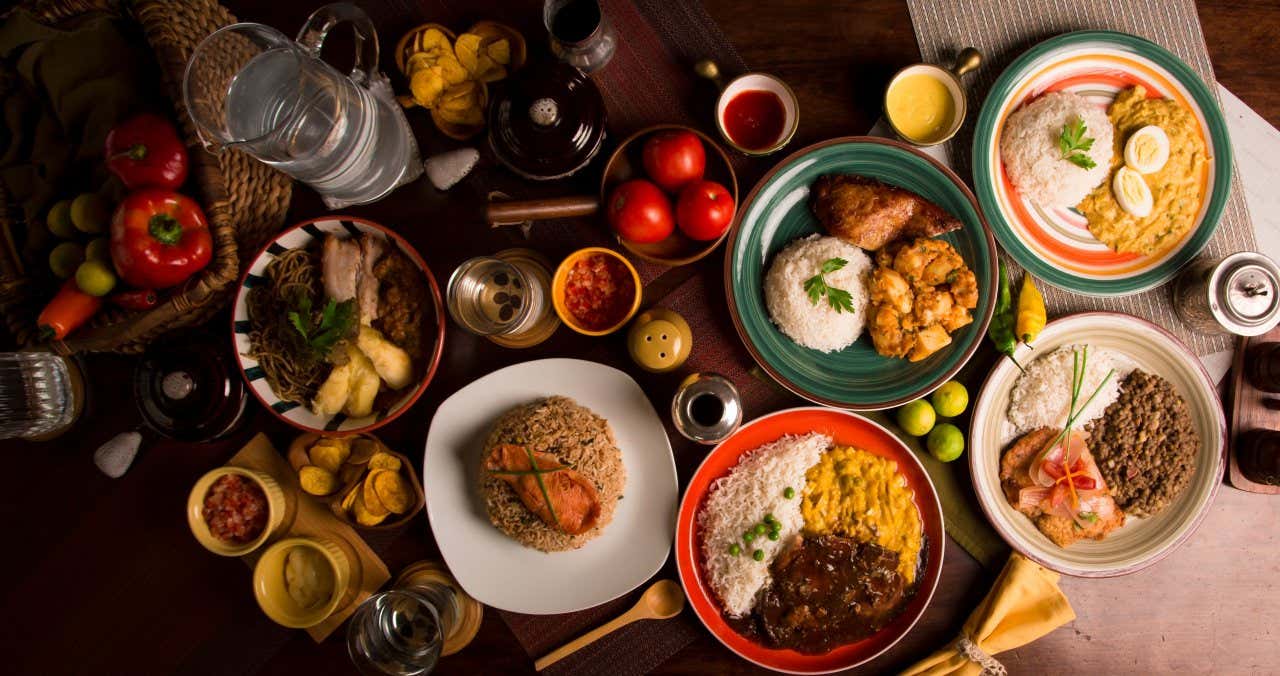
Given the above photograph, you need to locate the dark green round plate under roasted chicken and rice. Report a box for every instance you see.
[724,136,996,411]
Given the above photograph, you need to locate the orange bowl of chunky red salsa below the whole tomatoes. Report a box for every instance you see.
[552,247,640,335]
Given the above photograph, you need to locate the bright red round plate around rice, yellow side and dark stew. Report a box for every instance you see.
[676,407,945,673]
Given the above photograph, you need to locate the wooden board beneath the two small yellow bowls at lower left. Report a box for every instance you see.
[227,433,390,643]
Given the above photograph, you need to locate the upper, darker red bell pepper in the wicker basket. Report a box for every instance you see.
[104,113,187,189]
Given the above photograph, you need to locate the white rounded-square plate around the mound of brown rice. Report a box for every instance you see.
[422,358,677,615]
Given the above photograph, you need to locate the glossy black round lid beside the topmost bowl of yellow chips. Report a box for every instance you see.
[489,63,605,181]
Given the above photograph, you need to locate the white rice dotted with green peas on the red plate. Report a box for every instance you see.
[698,433,831,617]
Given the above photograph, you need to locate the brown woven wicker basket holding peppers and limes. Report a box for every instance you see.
[0,0,292,353]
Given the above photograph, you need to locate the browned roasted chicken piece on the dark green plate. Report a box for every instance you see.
[809,174,960,251]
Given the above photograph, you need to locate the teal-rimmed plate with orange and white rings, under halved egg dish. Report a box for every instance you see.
[973,31,1231,296]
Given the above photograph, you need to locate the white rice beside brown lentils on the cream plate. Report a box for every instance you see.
[1009,346,1133,434]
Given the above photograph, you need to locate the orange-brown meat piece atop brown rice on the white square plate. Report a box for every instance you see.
[484,444,600,535]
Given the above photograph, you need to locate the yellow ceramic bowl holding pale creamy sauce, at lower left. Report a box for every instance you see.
[253,536,351,629]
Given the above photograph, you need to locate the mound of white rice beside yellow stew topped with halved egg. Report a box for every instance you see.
[1000,92,1115,206]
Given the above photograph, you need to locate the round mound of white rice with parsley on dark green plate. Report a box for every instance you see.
[764,234,872,352]
